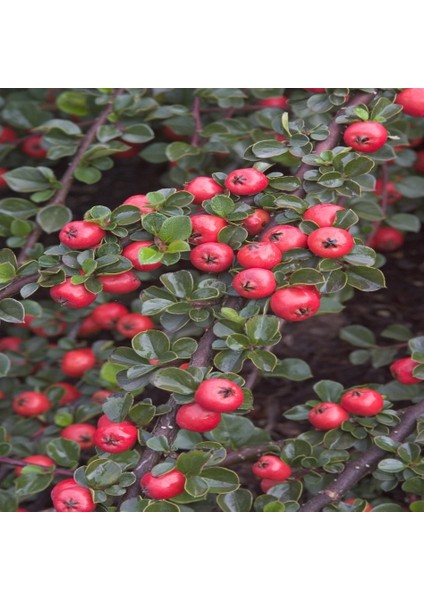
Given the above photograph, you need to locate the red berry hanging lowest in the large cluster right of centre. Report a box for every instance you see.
[270,285,321,321]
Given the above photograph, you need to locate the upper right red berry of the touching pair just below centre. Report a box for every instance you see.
[194,378,244,412]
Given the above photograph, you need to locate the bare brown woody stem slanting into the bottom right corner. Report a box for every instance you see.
[300,400,424,512]
